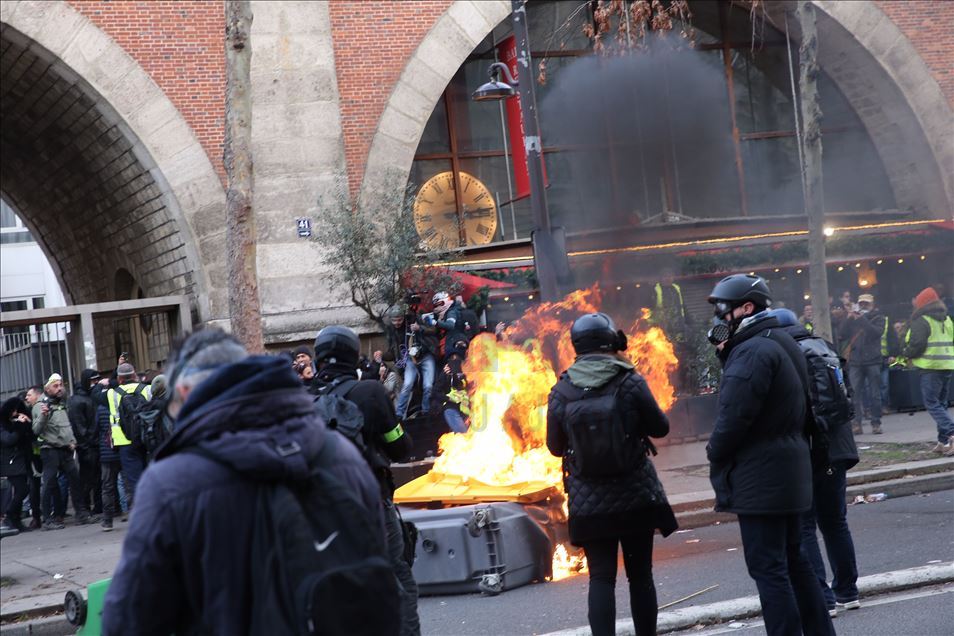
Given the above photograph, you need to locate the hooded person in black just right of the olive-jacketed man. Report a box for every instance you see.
[66,369,103,515]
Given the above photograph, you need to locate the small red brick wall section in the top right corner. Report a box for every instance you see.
[876,0,954,106]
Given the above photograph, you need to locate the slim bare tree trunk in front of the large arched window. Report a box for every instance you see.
[795,0,832,341]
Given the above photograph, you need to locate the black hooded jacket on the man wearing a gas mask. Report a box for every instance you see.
[706,313,812,515]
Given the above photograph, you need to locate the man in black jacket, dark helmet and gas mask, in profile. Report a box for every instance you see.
[706,274,834,636]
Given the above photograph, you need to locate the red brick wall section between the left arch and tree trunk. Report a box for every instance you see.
[67,0,225,181]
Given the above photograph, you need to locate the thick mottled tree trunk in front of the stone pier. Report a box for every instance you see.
[222,0,264,351]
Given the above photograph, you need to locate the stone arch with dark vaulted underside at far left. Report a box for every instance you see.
[0,0,228,320]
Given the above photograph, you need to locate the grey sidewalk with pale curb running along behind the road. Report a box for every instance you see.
[0,412,954,621]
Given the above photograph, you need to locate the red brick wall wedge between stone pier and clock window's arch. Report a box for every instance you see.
[329,0,451,192]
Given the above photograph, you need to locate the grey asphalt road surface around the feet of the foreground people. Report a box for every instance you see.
[419,491,954,636]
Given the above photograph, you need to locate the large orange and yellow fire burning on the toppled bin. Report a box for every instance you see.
[424,286,678,580]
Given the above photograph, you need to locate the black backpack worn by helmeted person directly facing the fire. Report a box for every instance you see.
[554,371,648,478]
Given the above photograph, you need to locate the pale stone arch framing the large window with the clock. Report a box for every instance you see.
[361,0,954,215]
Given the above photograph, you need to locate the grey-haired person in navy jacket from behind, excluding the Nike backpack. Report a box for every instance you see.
[102,328,384,636]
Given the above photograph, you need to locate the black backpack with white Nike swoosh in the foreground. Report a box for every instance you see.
[185,433,401,636]
